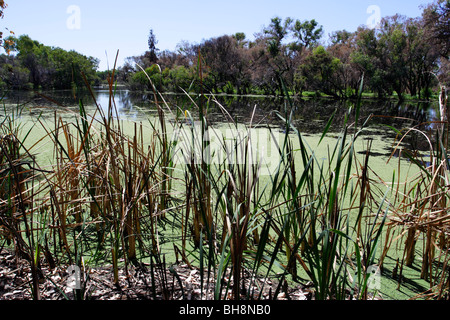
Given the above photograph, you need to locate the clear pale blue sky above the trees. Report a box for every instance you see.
[0,0,433,70]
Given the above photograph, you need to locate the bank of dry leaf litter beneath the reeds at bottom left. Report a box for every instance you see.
[0,250,312,300]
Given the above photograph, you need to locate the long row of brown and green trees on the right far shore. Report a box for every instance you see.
[118,0,450,99]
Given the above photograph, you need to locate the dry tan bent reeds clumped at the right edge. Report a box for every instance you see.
[384,87,450,299]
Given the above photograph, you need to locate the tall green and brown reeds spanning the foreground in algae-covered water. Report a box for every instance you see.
[0,67,448,300]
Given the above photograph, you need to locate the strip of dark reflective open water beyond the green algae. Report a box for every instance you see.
[0,90,437,149]
